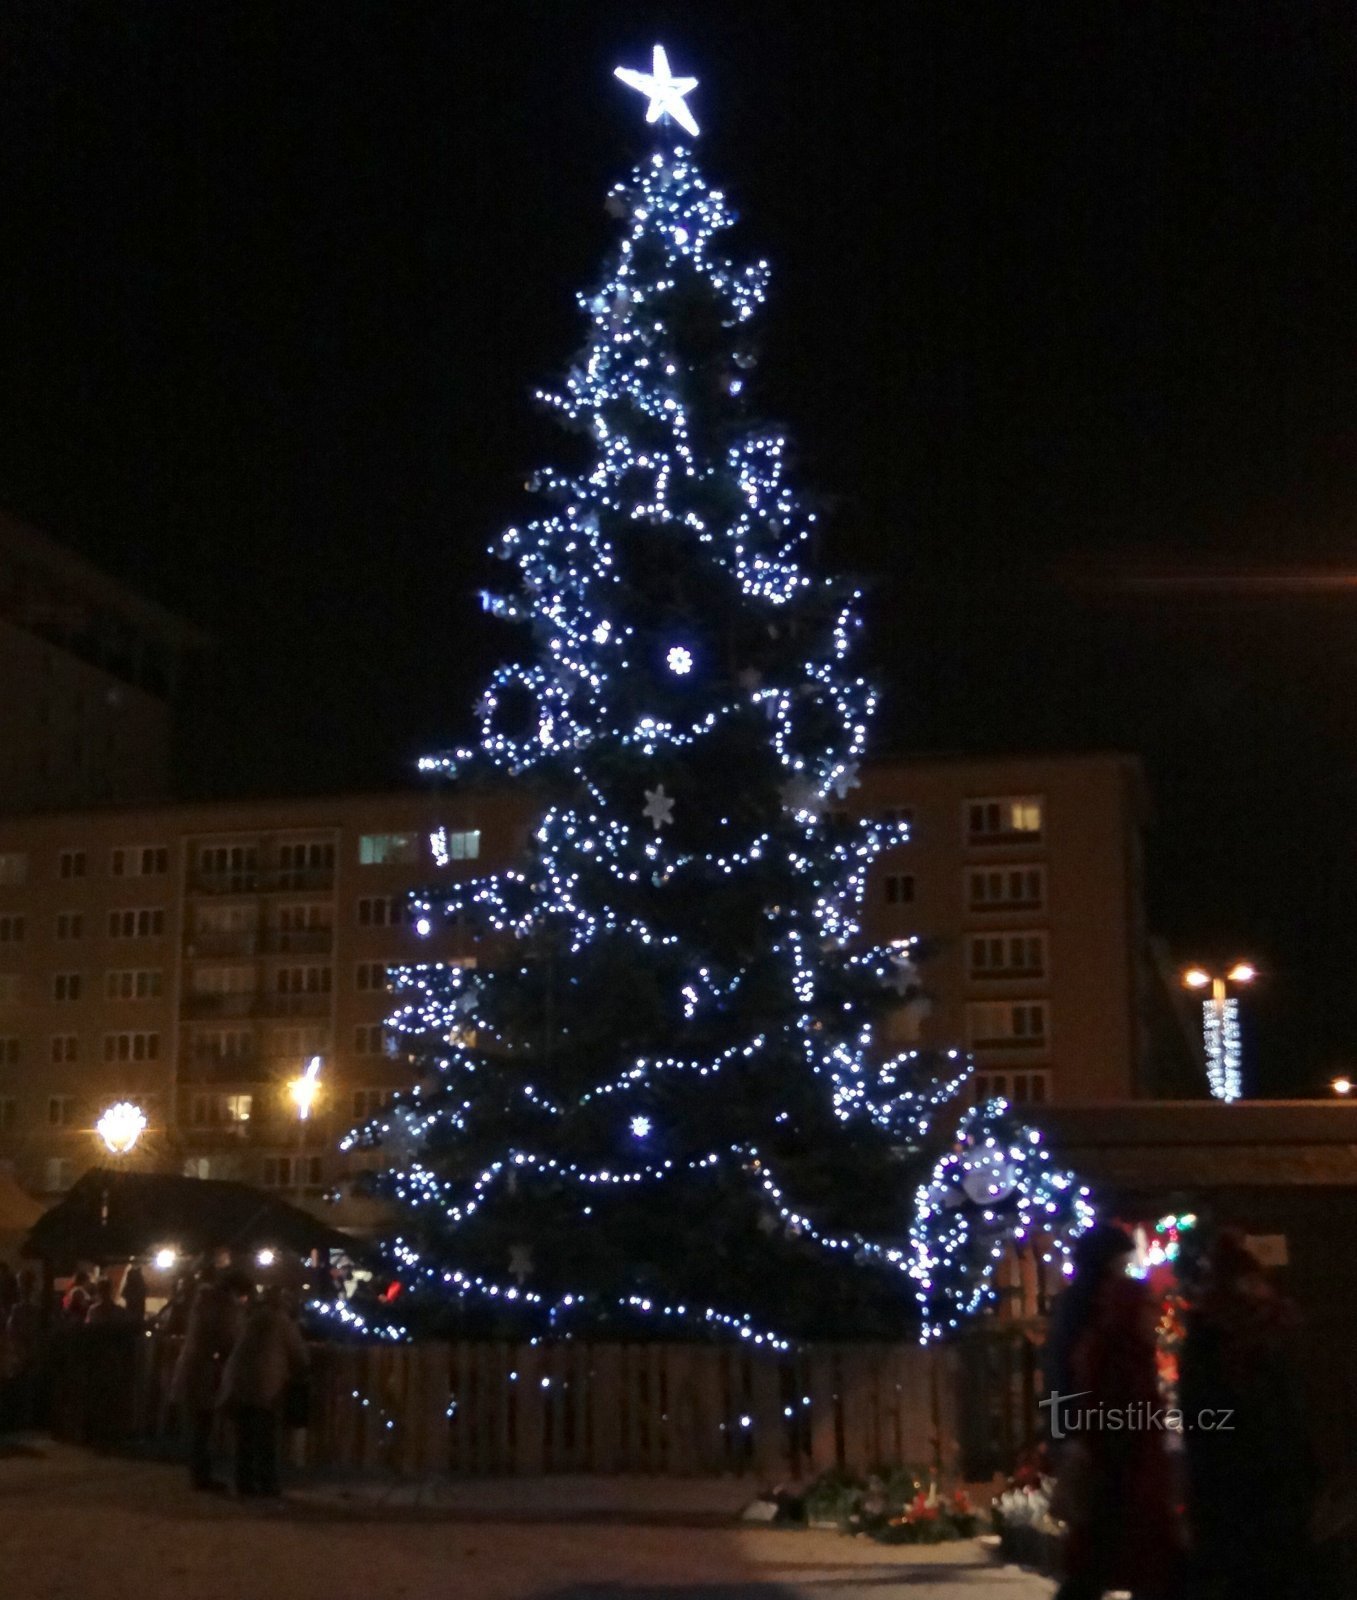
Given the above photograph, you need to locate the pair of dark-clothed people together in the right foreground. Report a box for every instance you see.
[1047,1224,1317,1600]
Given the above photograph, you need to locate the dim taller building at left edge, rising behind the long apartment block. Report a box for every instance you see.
[0,515,205,811]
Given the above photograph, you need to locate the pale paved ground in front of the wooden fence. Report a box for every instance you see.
[0,1445,1051,1600]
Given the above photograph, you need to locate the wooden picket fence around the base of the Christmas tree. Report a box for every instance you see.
[53,1334,962,1483]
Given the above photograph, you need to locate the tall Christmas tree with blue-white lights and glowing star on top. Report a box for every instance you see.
[339,50,1087,1342]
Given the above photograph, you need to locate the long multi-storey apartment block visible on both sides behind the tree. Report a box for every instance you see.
[0,757,1171,1200]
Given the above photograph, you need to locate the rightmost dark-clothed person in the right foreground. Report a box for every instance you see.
[1179,1232,1315,1600]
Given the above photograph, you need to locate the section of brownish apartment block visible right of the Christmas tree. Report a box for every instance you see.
[851,755,1158,1104]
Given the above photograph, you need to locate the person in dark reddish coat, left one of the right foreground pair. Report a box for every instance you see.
[1048,1224,1179,1600]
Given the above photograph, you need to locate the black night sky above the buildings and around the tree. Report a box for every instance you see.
[0,0,1357,1090]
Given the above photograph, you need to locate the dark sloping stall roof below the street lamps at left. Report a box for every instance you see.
[22,1166,360,1262]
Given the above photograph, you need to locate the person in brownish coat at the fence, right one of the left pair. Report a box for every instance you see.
[218,1290,307,1496]
